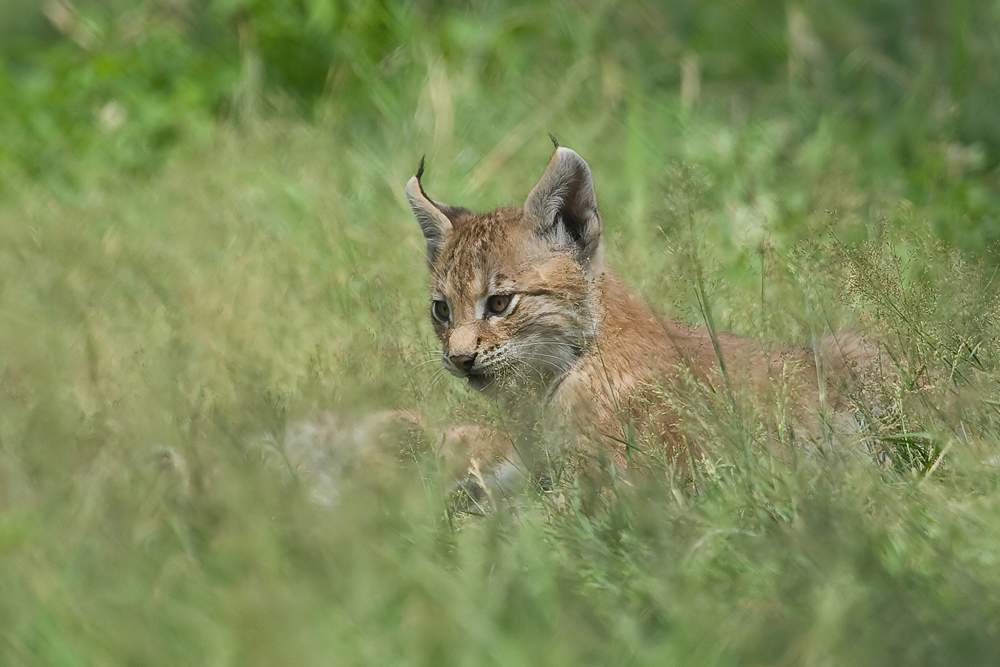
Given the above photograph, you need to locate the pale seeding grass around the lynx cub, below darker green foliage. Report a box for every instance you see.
[0,61,1000,665]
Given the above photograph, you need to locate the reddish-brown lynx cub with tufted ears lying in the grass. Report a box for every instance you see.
[406,144,868,472]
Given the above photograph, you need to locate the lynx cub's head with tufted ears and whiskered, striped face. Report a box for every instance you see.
[406,144,604,392]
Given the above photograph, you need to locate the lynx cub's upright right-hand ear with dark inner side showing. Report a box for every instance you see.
[524,144,601,272]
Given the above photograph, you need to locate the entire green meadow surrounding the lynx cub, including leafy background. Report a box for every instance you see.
[0,0,1000,667]
